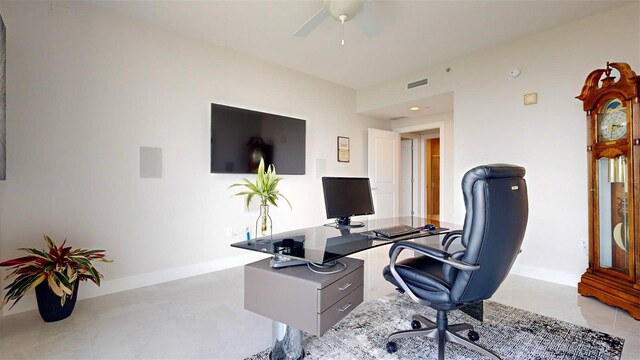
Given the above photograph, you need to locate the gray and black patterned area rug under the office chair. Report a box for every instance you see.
[247,294,624,360]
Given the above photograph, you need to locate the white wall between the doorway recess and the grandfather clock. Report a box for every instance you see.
[357,3,640,285]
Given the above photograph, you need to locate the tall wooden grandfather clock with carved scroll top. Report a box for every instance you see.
[577,63,640,319]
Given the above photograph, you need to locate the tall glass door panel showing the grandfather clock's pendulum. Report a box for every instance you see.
[597,155,631,276]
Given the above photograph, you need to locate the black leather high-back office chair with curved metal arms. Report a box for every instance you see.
[383,164,528,360]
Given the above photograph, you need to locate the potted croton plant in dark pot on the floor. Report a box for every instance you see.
[0,235,111,322]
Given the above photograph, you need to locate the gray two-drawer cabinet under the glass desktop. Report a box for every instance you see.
[244,257,364,336]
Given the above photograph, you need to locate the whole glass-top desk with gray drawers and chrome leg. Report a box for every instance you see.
[231,217,482,359]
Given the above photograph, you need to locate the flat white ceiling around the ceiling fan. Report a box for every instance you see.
[87,0,633,89]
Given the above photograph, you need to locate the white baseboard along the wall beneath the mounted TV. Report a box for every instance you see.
[2,252,266,316]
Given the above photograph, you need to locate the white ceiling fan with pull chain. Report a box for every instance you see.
[293,0,382,45]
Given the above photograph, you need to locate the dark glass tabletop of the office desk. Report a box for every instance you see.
[231,217,459,267]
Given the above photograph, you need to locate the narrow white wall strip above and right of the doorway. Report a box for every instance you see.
[391,112,460,222]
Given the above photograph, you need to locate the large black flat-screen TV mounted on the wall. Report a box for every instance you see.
[211,104,306,175]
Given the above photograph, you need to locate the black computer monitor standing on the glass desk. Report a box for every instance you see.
[322,177,374,227]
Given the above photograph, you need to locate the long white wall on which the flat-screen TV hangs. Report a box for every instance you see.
[0,1,390,310]
